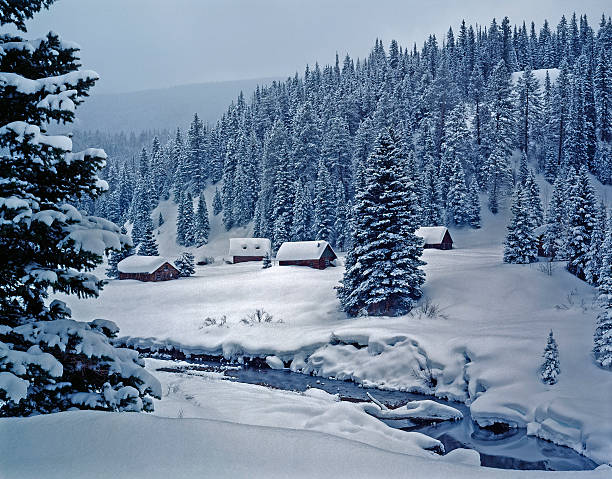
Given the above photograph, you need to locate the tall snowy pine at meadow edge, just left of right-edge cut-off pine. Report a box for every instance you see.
[565,166,597,279]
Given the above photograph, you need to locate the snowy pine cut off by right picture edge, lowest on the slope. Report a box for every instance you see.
[593,221,612,369]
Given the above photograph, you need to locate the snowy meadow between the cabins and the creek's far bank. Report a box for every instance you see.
[50,190,612,468]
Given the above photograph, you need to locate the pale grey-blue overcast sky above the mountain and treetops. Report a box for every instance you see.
[17,0,612,92]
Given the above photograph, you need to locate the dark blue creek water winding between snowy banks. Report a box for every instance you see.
[157,362,597,471]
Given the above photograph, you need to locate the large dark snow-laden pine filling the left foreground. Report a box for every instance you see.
[0,4,161,416]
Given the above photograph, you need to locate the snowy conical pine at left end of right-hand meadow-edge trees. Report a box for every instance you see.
[504,185,538,264]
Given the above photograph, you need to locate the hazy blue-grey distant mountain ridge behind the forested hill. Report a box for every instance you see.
[75,78,278,132]
